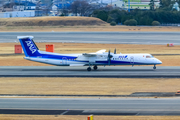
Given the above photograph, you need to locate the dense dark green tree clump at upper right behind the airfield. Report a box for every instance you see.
[92,3,180,25]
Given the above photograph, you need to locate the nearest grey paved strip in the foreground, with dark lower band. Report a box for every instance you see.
[0,98,180,116]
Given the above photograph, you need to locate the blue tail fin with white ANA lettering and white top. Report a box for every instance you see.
[17,36,41,57]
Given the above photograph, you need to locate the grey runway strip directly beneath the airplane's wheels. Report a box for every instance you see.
[0,66,180,78]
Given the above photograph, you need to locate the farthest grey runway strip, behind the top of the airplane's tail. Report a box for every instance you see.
[0,32,180,45]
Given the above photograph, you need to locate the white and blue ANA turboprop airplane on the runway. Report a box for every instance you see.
[17,36,162,71]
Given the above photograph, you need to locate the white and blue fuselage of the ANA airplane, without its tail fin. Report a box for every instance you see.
[25,51,162,66]
